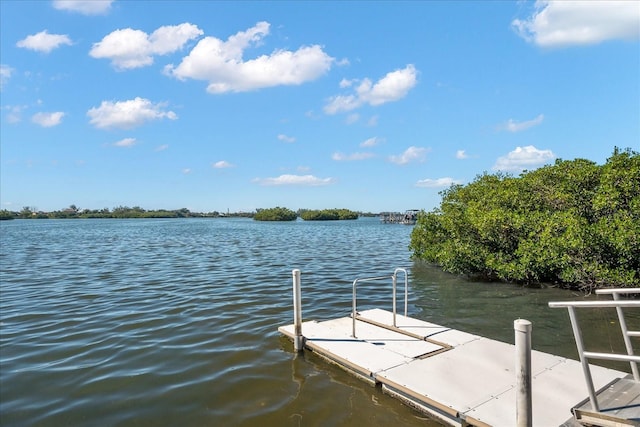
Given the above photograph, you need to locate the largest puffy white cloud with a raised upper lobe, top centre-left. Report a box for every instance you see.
[165,22,334,94]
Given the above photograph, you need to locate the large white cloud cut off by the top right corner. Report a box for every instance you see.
[511,0,640,47]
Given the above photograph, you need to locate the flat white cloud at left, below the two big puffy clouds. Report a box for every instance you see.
[87,97,178,129]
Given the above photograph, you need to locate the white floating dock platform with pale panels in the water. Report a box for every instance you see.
[278,271,640,427]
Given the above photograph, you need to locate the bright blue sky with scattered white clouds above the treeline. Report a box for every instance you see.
[0,0,640,212]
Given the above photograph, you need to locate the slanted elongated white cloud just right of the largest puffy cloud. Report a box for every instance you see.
[324,64,418,114]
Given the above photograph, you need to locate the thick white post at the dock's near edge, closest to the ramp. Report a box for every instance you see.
[513,319,533,427]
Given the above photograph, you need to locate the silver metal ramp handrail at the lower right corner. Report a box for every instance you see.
[549,288,640,412]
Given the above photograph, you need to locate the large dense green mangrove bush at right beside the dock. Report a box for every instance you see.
[409,148,640,289]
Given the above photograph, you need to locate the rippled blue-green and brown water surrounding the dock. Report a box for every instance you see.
[0,218,640,427]
